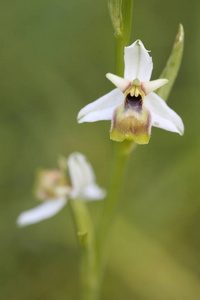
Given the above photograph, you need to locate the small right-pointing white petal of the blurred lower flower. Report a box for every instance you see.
[82,183,106,200]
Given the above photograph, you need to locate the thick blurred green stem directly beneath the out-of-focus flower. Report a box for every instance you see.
[69,199,99,300]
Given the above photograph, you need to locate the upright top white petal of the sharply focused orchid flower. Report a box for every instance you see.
[124,40,153,81]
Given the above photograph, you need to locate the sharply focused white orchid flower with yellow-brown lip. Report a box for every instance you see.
[78,40,184,144]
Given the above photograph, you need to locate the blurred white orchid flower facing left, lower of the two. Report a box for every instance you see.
[17,152,106,226]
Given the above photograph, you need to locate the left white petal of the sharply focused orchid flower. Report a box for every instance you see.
[78,89,124,123]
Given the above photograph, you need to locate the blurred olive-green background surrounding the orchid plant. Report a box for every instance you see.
[0,0,200,300]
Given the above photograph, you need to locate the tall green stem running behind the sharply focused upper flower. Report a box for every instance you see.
[97,0,133,284]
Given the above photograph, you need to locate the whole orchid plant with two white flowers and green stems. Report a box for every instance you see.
[17,0,184,300]
